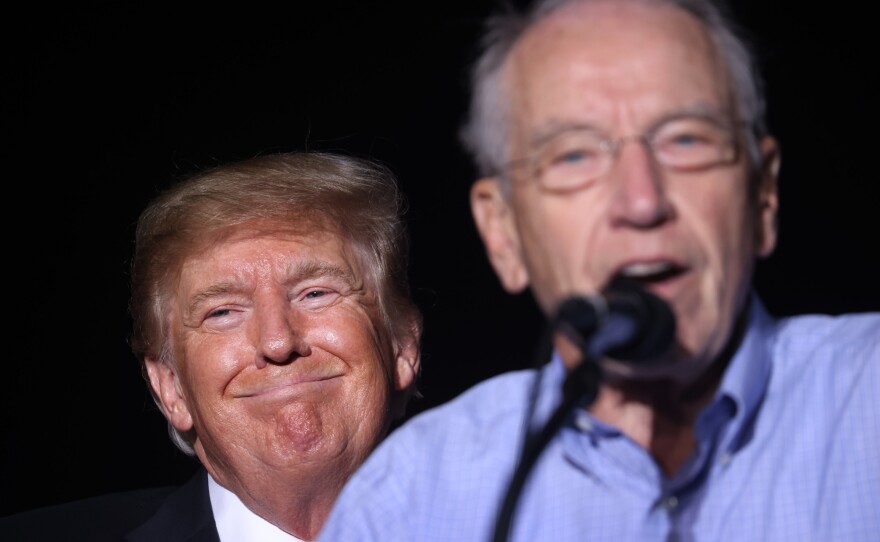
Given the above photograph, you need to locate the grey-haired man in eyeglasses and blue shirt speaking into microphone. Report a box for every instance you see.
[319,0,880,542]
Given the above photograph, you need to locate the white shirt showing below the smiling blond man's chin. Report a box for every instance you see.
[208,476,303,542]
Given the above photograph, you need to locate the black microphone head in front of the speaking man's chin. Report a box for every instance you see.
[555,277,675,364]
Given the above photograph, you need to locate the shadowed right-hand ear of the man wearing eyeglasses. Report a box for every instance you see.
[755,136,781,258]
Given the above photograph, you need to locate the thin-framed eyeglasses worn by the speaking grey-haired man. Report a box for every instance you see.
[508,115,743,192]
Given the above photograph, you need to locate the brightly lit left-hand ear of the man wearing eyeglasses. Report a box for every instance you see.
[471,177,529,294]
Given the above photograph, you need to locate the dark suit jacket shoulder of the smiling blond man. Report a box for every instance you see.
[0,469,220,542]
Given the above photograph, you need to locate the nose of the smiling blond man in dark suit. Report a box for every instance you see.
[254,303,311,369]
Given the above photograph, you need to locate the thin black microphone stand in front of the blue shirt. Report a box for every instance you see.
[492,352,602,542]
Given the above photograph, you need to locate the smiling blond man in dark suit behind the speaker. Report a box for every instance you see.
[0,153,421,542]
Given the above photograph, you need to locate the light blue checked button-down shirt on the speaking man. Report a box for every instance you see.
[319,295,880,542]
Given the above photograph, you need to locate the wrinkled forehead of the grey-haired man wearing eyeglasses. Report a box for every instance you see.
[504,0,733,134]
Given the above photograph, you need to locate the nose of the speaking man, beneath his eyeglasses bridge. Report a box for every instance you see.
[610,137,674,228]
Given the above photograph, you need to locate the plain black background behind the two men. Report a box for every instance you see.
[0,0,880,515]
